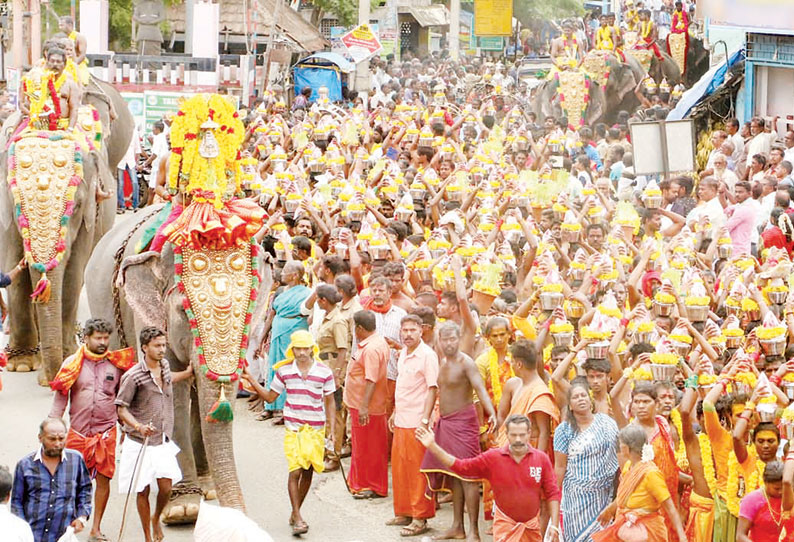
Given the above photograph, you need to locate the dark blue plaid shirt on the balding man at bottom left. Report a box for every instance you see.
[11,449,91,542]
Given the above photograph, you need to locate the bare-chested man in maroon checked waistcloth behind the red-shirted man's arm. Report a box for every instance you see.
[421,321,496,541]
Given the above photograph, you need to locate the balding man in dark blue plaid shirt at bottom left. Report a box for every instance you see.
[11,418,91,542]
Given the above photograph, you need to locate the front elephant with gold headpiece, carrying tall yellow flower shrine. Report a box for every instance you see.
[86,94,272,523]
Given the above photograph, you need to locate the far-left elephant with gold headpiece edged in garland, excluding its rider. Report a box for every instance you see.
[0,81,134,384]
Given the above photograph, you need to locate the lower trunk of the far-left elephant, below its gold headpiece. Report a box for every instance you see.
[30,265,64,382]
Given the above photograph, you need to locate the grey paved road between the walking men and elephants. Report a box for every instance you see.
[0,373,464,542]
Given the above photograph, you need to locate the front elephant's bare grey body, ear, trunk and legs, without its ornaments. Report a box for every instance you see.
[86,206,272,524]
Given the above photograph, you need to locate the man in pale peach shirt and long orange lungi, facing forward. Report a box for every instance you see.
[386,314,438,536]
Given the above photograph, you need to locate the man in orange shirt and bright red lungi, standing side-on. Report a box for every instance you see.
[344,310,391,499]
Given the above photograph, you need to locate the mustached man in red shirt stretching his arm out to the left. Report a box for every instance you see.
[416,414,560,542]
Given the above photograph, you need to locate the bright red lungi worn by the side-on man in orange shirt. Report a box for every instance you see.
[347,408,389,497]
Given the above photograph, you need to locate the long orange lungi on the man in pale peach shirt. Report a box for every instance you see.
[391,427,436,519]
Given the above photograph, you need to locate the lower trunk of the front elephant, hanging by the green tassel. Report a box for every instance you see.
[193,376,245,512]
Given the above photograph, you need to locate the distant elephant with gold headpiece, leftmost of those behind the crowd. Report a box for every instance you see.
[531,70,606,128]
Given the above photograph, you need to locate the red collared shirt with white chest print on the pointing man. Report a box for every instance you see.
[452,446,560,523]
